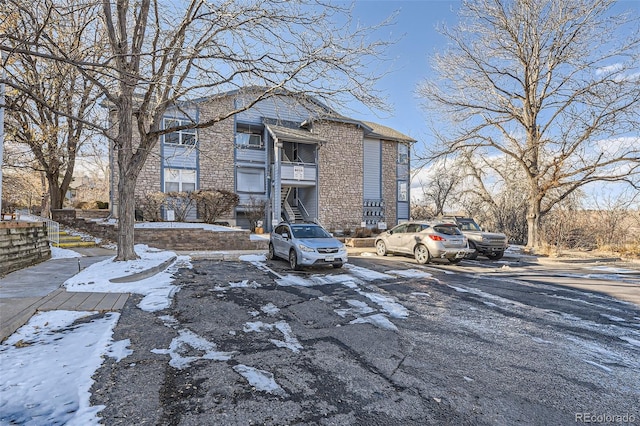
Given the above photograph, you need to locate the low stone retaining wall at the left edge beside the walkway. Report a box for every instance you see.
[0,222,51,276]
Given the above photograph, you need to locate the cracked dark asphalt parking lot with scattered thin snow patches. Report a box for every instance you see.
[91,256,640,425]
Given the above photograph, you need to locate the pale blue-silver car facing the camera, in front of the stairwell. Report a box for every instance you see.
[268,223,347,269]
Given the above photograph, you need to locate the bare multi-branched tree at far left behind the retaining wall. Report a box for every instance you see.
[3,1,100,214]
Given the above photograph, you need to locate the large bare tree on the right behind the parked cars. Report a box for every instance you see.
[417,0,640,247]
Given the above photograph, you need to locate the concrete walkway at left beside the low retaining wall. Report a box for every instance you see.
[0,247,120,342]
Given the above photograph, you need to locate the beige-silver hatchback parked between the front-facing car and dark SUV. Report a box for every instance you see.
[375,221,471,264]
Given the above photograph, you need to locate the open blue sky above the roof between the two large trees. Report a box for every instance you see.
[347,0,640,157]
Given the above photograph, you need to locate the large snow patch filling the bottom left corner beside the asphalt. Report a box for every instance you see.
[0,311,126,425]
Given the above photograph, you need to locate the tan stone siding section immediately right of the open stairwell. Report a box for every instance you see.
[313,122,364,229]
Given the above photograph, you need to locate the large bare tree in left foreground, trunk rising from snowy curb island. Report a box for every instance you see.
[0,0,392,260]
